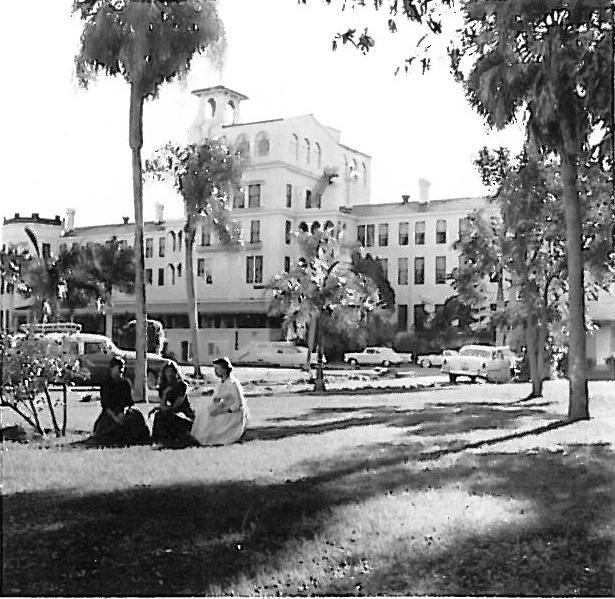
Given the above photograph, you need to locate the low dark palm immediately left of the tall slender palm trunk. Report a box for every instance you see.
[84,236,135,337]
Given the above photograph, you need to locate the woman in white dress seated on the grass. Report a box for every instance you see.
[190,357,248,445]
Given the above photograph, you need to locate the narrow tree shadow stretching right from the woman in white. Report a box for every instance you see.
[243,402,559,441]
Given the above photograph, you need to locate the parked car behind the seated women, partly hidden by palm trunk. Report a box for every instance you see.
[48,333,170,389]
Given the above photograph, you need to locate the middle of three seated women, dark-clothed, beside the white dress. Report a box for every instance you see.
[152,362,194,447]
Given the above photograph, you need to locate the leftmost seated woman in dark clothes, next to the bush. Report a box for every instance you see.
[90,356,150,446]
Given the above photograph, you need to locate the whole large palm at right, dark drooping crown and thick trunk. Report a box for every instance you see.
[456,0,613,420]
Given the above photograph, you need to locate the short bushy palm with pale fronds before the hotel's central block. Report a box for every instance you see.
[268,229,380,391]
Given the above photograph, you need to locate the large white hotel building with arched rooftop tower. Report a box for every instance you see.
[0,86,615,363]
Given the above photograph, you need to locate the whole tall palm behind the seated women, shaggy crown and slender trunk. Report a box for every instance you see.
[73,0,223,401]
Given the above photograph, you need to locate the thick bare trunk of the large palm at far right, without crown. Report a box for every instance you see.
[560,149,589,420]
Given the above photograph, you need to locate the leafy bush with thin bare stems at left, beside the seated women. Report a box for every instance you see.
[0,334,89,437]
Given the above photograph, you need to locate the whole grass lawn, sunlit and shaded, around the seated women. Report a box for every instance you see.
[2,381,615,596]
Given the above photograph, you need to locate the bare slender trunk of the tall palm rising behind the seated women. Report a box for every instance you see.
[129,83,147,402]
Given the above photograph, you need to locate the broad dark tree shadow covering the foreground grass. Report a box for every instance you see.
[3,444,615,596]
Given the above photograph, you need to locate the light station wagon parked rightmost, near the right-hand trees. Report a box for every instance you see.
[442,345,511,383]
